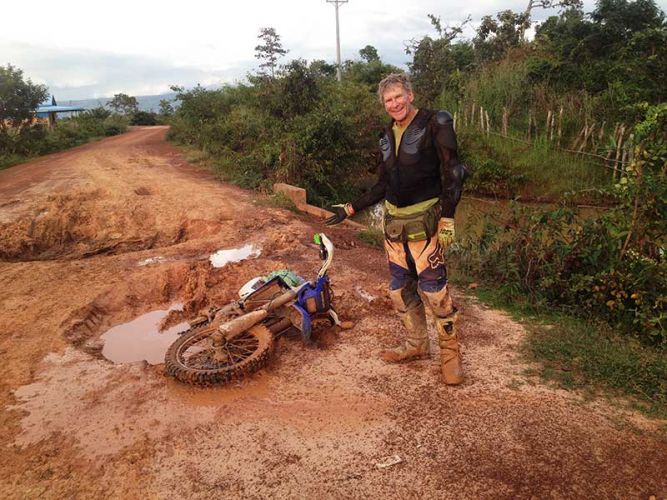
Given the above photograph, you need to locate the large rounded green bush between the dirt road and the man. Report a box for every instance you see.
[168,74,382,205]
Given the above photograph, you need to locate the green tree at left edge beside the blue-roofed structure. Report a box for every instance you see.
[0,64,48,130]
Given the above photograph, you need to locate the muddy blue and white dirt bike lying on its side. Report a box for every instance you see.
[165,233,344,385]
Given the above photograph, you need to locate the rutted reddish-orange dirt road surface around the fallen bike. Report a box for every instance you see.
[0,127,667,498]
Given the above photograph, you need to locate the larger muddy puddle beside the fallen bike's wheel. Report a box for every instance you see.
[102,304,190,365]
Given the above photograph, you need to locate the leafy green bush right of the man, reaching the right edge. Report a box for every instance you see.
[453,104,667,347]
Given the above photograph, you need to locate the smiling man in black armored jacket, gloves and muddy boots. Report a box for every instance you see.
[326,73,466,385]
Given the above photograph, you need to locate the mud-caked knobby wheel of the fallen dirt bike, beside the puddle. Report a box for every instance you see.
[165,322,273,386]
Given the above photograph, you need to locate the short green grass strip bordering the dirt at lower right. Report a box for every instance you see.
[455,277,667,418]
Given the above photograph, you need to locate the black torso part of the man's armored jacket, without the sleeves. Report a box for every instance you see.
[380,109,442,207]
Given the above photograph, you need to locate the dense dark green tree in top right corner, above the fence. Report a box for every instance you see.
[531,0,667,100]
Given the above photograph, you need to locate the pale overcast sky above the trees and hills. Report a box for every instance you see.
[0,0,667,100]
